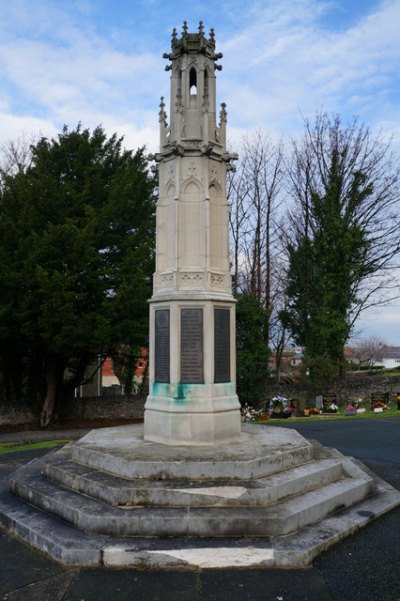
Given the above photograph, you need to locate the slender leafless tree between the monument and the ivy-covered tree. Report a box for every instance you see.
[228,132,284,342]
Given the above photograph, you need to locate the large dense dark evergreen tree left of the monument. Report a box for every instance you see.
[0,125,155,425]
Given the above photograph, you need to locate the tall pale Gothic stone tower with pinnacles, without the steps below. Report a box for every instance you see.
[144,22,240,445]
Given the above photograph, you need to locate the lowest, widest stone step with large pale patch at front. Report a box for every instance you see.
[0,466,400,570]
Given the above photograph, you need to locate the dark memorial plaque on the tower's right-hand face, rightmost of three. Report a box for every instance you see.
[214,309,231,383]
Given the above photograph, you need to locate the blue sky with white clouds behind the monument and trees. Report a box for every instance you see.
[0,0,400,345]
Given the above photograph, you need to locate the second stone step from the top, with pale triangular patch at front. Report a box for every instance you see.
[42,448,343,507]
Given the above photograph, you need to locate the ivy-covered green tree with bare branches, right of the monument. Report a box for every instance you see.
[281,115,399,385]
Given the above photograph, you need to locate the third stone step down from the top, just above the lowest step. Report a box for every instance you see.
[11,464,373,537]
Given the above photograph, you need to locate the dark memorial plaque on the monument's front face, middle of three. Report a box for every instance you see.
[181,309,204,384]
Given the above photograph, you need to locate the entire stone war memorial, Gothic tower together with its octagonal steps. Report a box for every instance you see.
[0,23,400,569]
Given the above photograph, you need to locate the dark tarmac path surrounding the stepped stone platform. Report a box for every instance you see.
[0,418,400,601]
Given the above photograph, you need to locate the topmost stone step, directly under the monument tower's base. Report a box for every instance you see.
[69,424,314,481]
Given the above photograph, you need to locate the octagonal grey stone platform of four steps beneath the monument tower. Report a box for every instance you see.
[0,425,400,567]
